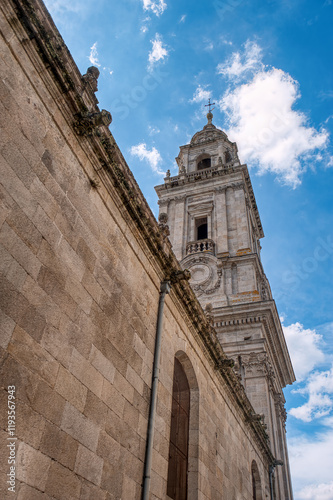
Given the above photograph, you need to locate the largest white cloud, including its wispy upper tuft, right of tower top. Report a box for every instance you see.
[218,42,328,188]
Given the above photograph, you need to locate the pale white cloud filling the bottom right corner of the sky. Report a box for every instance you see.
[288,429,333,500]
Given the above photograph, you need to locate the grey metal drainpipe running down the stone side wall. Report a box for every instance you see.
[142,281,171,500]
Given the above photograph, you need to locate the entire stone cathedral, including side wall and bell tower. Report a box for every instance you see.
[0,0,295,500]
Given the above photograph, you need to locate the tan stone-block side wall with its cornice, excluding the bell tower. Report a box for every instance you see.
[0,0,287,500]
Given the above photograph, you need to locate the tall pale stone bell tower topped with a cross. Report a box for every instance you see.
[155,111,295,500]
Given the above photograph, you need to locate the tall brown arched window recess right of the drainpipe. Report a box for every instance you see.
[167,358,190,500]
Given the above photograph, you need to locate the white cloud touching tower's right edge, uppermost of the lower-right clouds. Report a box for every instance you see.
[281,318,325,381]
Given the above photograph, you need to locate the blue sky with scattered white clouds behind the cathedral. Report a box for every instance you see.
[46,0,333,500]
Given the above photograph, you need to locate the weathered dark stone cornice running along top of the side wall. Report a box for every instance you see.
[5,0,273,462]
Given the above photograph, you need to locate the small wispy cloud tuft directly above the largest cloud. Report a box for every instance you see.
[217,40,264,79]
